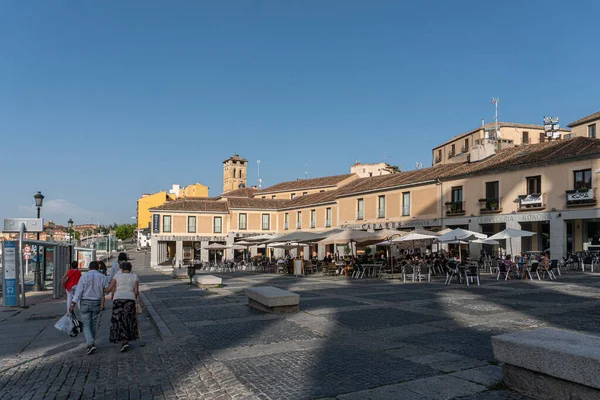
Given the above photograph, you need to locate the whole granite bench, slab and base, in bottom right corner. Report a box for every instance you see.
[492,328,600,400]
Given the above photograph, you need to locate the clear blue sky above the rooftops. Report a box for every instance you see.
[0,0,600,224]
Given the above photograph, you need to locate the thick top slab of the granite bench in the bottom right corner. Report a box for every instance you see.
[492,328,600,390]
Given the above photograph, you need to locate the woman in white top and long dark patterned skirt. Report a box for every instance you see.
[105,262,140,352]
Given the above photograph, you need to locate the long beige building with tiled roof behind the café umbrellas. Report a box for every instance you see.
[151,137,600,265]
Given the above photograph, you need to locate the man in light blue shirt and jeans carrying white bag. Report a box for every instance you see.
[69,261,109,355]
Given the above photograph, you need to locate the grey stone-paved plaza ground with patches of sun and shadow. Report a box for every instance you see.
[0,253,600,400]
